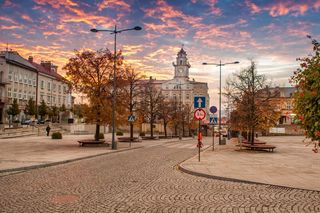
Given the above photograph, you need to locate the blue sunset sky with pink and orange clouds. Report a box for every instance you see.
[0,0,320,105]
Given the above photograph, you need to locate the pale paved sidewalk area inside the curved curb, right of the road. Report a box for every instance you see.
[180,136,320,191]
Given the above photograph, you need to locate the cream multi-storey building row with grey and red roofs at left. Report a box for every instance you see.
[0,51,72,123]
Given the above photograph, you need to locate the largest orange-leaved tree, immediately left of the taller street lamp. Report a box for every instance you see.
[63,49,117,140]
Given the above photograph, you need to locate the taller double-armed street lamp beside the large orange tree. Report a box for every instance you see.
[90,25,142,149]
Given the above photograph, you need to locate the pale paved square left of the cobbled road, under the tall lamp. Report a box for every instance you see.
[0,134,188,175]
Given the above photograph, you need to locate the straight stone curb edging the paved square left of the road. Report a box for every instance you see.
[0,146,144,175]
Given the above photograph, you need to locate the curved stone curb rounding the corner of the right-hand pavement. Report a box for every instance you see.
[175,151,320,192]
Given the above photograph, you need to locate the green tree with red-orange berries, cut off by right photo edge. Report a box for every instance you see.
[291,36,320,148]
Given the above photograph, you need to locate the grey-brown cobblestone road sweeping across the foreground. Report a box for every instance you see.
[0,141,320,212]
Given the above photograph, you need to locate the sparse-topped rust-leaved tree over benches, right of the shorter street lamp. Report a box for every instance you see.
[226,62,279,144]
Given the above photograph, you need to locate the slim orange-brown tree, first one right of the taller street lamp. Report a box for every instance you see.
[121,66,144,141]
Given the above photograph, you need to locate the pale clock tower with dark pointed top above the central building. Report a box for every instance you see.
[172,46,191,80]
